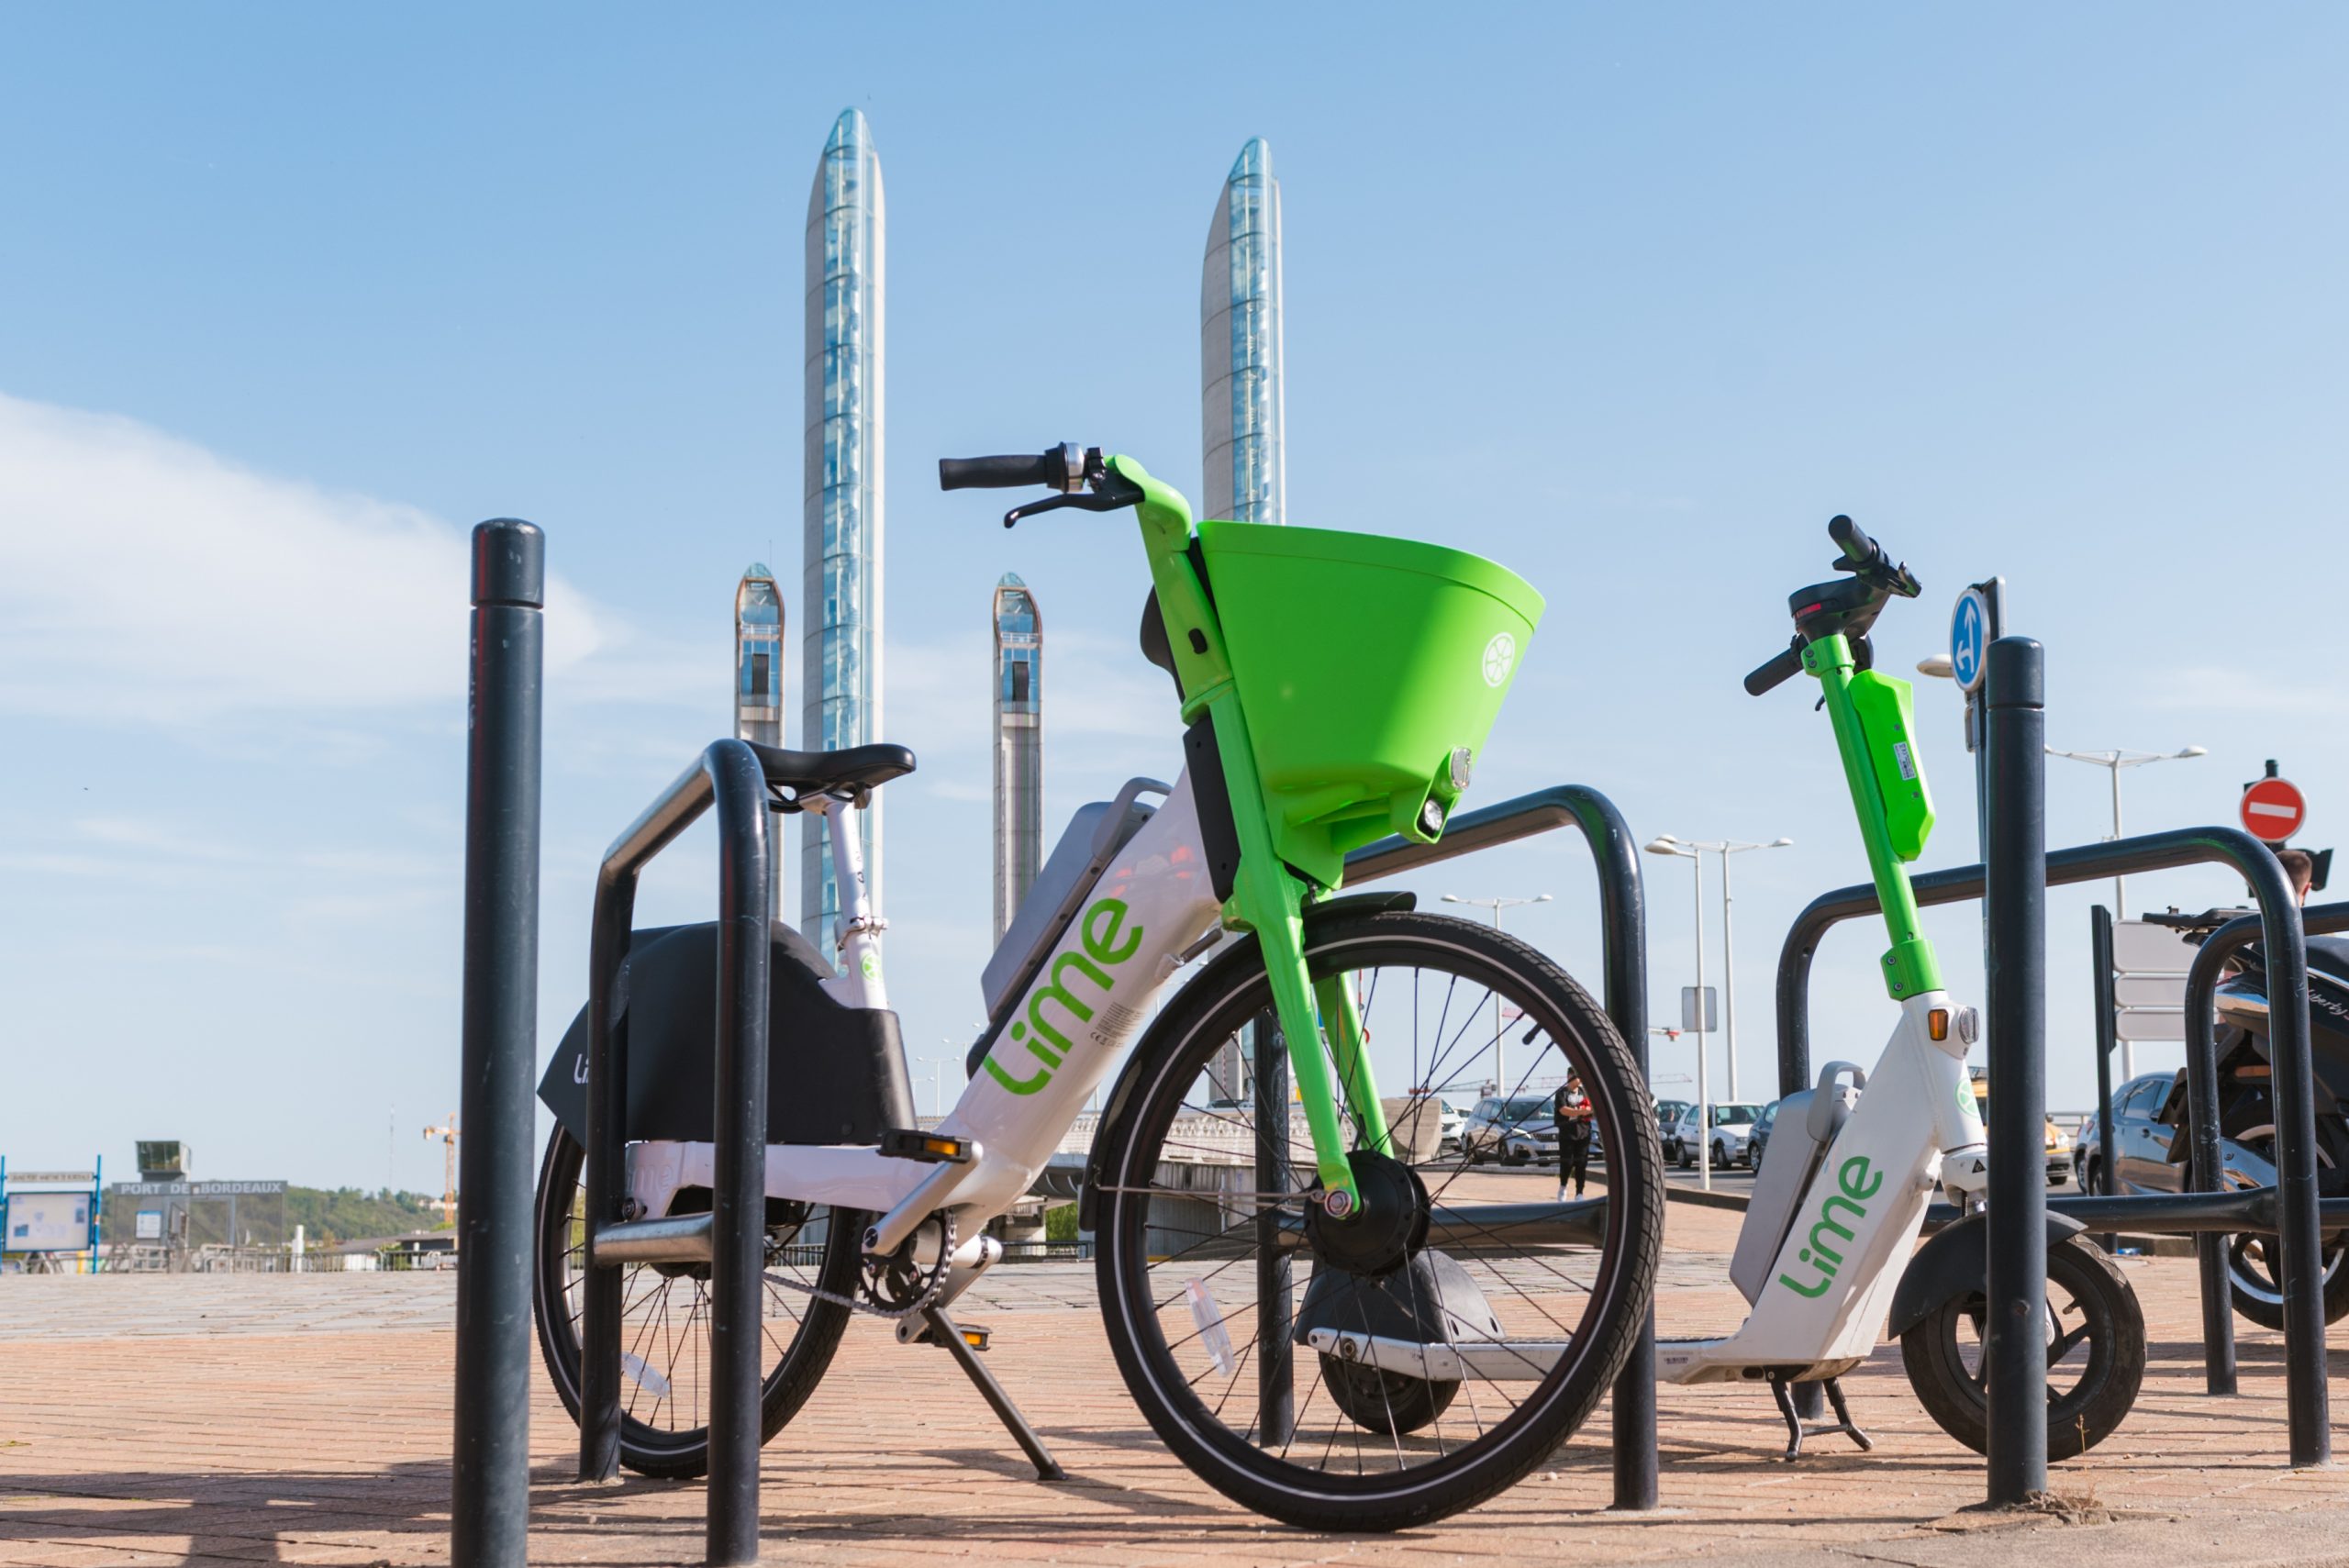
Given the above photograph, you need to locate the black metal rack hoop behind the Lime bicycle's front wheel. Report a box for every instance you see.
[1353,784,1658,1509]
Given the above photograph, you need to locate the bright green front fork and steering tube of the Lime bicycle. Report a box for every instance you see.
[1108,458,1388,1192]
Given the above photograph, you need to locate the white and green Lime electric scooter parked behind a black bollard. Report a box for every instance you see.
[1315,517,2144,1458]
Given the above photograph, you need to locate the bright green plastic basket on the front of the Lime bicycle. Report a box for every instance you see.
[1198,521,1541,887]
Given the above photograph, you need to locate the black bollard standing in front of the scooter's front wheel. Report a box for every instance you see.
[1983,636,2048,1505]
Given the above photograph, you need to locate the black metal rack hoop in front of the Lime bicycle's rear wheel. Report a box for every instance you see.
[580,740,775,1563]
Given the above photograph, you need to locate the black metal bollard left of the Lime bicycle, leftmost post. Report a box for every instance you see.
[449,518,547,1568]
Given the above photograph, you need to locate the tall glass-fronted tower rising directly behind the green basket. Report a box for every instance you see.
[1198,136,1287,524]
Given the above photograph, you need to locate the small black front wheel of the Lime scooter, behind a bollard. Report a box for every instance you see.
[1900,1235,2144,1460]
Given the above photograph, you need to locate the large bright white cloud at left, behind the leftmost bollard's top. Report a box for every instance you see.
[0,395,618,723]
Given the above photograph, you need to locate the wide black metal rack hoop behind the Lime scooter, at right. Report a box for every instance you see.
[1778,639,2321,1467]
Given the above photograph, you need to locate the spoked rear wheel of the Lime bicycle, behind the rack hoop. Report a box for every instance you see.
[536,1127,867,1479]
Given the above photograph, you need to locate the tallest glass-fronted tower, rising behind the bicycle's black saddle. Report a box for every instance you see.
[798,108,888,951]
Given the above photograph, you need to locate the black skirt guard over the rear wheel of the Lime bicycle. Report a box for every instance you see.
[538,922,916,1143]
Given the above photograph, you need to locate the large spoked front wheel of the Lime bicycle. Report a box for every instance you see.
[1092,911,1663,1530]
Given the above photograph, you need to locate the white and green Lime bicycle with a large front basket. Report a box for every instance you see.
[538,446,1663,1530]
